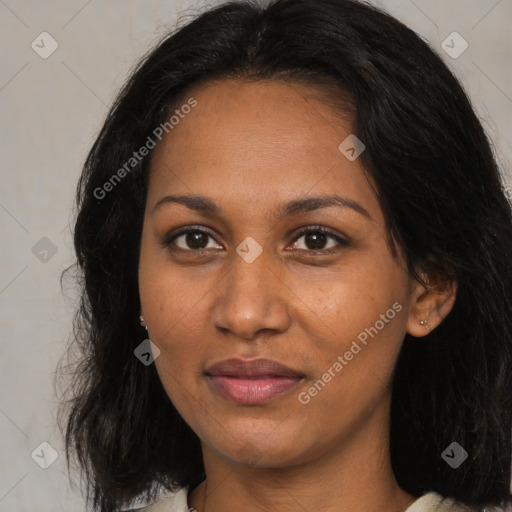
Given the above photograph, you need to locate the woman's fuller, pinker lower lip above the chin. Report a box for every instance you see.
[208,375,302,404]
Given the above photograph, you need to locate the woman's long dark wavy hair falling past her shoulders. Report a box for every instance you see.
[61,0,512,512]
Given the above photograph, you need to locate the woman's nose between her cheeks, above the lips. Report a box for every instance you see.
[212,243,291,340]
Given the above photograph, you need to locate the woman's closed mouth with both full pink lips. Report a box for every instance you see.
[205,359,304,405]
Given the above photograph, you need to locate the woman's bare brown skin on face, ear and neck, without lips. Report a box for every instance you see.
[139,80,456,512]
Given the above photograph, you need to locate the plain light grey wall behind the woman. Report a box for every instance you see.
[0,0,512,512]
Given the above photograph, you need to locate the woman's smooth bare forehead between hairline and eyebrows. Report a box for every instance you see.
[148,80,380,223]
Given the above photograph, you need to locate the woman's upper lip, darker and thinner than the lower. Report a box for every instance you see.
[206,358,303,378]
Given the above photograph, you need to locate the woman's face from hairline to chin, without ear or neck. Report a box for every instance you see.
[139,80,424,467]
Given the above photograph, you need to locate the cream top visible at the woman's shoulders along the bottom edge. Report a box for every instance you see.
[137,487,469,512]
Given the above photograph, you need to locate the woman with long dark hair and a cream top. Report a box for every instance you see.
[58,0,512,512]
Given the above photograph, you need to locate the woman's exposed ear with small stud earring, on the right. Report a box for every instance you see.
[407,262,457,338]
